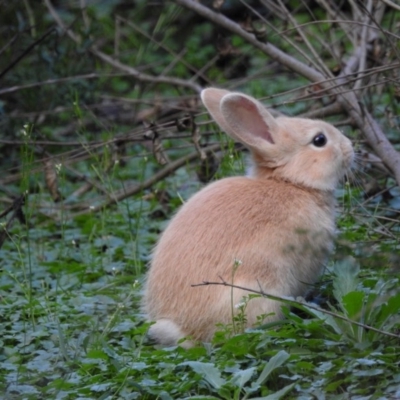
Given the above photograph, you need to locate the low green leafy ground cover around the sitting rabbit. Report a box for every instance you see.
[0,139,400,399]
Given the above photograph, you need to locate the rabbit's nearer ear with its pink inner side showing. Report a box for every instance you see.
[220,93,279,151]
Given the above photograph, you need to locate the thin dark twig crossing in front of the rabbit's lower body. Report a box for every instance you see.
[191,276,400,339]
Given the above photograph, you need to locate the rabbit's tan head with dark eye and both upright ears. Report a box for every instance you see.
[201,88,354,190]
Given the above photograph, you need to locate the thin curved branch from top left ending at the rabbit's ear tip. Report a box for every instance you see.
[44,0,202,93]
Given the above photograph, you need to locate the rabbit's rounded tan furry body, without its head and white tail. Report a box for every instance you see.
[145,177,334,340]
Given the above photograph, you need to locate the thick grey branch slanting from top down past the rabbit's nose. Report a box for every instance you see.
[175,0,400,185]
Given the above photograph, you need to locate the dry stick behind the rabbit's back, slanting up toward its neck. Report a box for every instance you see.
[73,143,222,217]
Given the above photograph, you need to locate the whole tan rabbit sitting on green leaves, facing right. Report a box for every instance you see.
[143,88,354,347]
